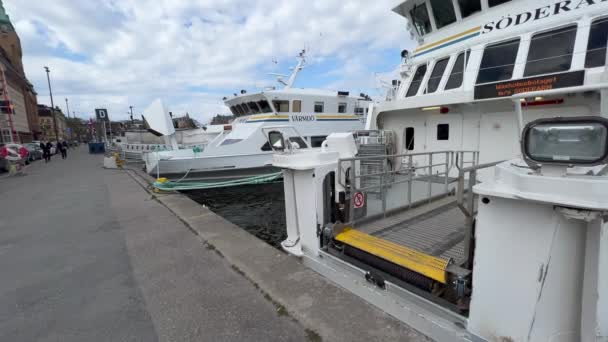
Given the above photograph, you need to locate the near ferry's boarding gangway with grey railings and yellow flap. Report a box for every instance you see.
[335,151,499,311]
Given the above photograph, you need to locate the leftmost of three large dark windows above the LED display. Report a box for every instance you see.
[477,38,519,83]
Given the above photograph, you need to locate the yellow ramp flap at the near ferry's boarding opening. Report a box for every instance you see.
[336,228,449,284]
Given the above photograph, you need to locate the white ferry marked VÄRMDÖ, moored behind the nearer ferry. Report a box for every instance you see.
[144,52,372,181]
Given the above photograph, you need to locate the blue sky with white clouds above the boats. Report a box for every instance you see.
[3,0,413,122]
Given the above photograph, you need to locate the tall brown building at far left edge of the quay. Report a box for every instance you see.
[0,0,41,142]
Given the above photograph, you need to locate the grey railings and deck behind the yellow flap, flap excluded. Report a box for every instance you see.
[338,151,498,269]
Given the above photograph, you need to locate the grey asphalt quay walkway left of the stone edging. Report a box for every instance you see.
[0,147,307,341]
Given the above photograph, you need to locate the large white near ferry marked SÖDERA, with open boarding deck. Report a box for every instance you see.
[269,0,608,342]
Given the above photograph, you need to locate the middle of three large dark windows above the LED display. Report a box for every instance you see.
[524,25,576,76]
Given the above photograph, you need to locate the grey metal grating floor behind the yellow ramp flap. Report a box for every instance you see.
[356,197,465,264]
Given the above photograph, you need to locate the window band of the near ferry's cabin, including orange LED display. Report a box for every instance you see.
[397,4,608,100]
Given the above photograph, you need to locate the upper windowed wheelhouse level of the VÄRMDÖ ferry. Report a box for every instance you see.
[225,89,371,117]
